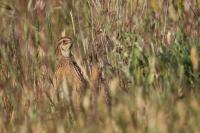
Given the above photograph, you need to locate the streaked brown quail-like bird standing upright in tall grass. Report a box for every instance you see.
[55,36,88,110]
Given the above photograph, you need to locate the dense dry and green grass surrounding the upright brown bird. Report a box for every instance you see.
[0,0,200,133]
